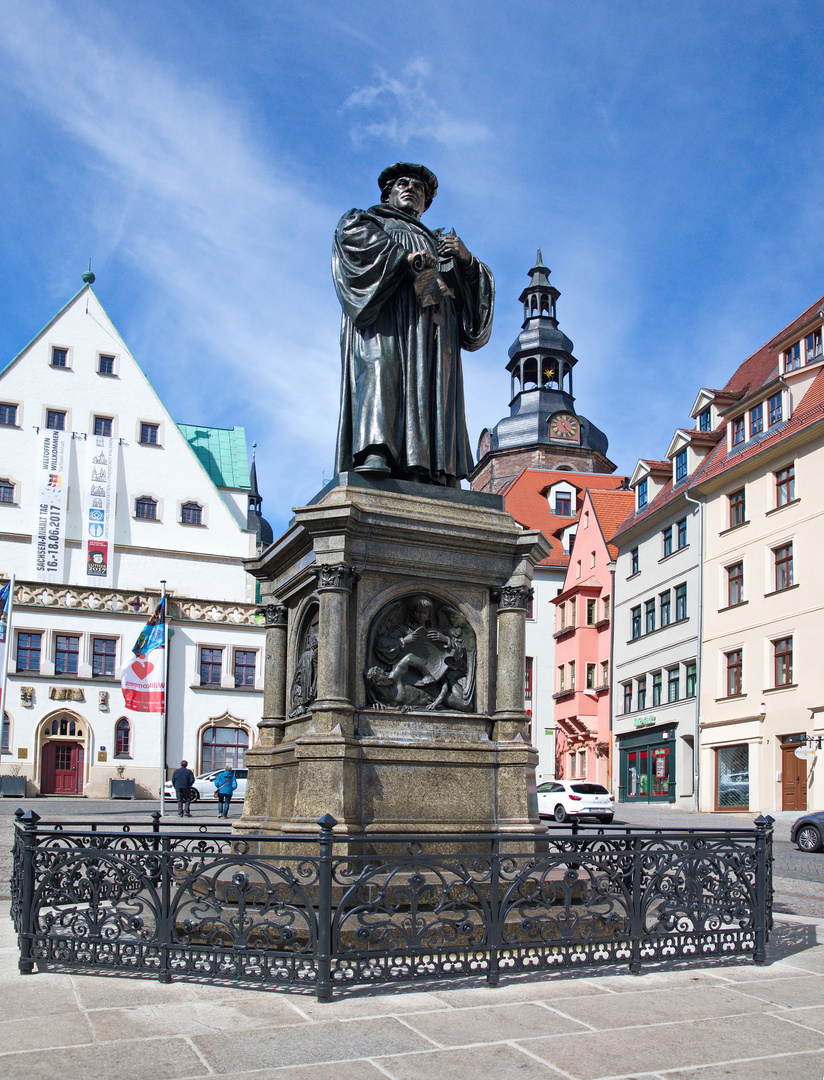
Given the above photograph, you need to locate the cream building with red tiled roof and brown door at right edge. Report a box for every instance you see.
[690,299,824,812]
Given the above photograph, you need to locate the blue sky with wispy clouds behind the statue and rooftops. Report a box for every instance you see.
[0,0,824,530]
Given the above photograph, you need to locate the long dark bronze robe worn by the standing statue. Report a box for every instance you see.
[332,205,495,484]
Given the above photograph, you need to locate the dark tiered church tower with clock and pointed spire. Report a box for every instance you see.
[469,247,616,491]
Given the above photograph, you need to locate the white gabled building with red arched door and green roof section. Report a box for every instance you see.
[0,275,264,797]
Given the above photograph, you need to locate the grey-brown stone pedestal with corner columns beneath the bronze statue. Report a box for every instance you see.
[234,473,550,840]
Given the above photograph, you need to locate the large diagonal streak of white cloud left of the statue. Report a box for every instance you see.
[0,3,339,515]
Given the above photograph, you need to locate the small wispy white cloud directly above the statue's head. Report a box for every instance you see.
[343,56,490,147]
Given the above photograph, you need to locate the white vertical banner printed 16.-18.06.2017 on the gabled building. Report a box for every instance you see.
[35,429,69,585]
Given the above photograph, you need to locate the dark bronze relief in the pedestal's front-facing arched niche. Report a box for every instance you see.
[364,594,475,713]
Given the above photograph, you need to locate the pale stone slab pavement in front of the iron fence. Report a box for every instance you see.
[0,904,824,1080]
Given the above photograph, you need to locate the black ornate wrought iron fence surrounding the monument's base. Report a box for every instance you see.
[12,811,772,1001]
